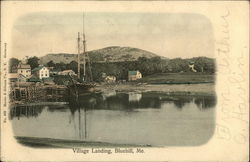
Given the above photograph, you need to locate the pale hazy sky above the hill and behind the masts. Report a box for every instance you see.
[12,12,214,58]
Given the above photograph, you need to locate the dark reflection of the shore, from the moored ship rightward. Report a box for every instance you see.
[69,92,216,112]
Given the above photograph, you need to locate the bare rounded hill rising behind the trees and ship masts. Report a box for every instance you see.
[40,46,164,64]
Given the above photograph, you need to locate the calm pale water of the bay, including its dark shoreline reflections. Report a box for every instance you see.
[10,92,216,146]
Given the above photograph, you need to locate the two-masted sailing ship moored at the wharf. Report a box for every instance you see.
[70,14,96,94]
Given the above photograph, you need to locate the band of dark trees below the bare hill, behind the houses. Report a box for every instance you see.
[10,56,216,81]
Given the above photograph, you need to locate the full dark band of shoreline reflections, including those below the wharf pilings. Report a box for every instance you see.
[10,92,216,119]
